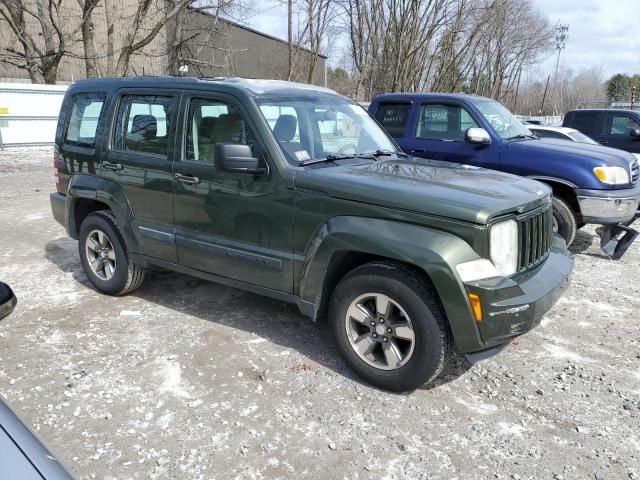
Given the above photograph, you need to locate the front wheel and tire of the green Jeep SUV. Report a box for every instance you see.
[329,262,452,392]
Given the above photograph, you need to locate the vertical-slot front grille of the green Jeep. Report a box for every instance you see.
[518,205,553,272]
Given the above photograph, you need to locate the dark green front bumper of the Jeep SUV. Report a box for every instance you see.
[462,239,573,359]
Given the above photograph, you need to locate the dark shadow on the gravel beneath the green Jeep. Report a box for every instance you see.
[45,238,466,389]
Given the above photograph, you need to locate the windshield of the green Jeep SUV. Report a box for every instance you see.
[257,96,399,165]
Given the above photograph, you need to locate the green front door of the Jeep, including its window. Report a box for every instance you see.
[174,93,293,292]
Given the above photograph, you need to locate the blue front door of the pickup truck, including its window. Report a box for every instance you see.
[405,101,498,168]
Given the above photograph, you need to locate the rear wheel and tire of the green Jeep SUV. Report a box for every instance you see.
[78,210,144,295]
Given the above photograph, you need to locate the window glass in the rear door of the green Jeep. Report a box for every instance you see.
[114,95,173,156]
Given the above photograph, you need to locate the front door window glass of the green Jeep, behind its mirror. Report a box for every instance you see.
[185,98,256,164]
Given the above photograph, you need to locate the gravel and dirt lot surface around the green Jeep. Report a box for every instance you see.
[0,149,640,480]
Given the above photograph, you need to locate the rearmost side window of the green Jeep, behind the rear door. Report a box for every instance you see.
[65,93,105,147]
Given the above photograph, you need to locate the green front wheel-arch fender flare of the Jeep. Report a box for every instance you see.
[298,216,482,349]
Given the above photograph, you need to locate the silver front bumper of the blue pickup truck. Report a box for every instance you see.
[576,183,640,225]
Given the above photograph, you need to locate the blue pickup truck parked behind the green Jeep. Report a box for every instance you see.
[369,93,640,258]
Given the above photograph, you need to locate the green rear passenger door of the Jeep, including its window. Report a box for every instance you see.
[100,89,180,262]
